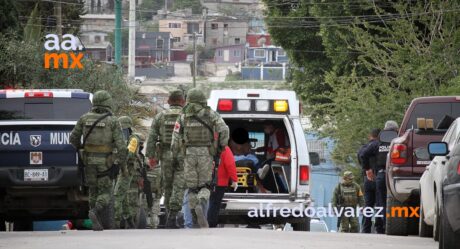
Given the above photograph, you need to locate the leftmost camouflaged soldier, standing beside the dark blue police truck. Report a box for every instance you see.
[70,91,127,231]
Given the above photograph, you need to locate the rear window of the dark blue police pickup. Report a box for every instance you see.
[0,98,91,121]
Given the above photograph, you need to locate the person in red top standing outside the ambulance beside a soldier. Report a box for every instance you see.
[208,146,238,227]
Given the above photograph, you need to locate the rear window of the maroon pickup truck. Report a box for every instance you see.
[406,103,460,130]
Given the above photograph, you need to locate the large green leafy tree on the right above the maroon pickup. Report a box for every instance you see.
[264,0,460,167]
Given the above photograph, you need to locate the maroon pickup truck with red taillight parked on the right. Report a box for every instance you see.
[386,96,460,235]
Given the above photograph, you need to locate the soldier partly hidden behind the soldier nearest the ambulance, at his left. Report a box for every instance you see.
[146,90,185,228]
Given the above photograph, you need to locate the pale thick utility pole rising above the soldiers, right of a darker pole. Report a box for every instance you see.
[128,0,136,80]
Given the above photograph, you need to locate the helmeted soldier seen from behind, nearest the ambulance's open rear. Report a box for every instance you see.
[171,88,229,227]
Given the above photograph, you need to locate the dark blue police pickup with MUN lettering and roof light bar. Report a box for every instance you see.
[0,90,92,230]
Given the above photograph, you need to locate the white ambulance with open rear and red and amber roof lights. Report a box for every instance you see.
[208,89,311,231]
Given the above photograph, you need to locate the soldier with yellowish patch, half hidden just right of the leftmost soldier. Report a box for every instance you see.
[114,116,145,228]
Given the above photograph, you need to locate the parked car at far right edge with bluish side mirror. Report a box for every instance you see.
[429,142,460,249]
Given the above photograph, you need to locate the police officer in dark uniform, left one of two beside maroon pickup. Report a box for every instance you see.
[358,129,385,233]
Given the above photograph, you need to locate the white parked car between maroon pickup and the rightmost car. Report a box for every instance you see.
[419,118,460,240]
